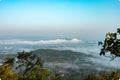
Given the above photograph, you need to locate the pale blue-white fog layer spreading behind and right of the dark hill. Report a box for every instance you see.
[0,38,120,69]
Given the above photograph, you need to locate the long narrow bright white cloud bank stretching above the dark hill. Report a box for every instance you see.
[0,38,82,45]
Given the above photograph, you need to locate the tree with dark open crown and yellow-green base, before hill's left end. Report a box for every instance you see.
[15,51,50,80]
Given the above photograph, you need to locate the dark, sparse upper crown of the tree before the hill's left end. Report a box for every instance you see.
[16,51,43,76]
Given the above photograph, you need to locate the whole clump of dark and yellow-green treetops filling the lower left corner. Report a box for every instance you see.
[0,51,60,80]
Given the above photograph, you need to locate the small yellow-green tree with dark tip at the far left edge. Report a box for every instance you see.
[0,57,19,80]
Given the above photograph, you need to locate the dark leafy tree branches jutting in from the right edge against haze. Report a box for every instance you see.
[98,28,120,60]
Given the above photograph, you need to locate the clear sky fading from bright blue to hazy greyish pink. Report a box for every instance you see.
[0,0,120,39]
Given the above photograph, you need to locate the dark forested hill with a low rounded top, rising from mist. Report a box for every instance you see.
[32,49,93,62]
